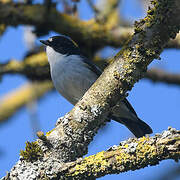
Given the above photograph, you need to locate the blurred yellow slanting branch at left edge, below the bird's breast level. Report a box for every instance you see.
[0,80,53,123]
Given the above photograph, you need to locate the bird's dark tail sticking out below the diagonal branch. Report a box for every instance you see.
[113,117,153,138]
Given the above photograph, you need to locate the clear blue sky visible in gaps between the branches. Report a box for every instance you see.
[0,0,180,180]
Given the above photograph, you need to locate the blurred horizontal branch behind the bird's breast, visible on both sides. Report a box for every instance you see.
[0,52,180,85]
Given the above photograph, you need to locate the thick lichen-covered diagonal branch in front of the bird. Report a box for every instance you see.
[1,0,180,179]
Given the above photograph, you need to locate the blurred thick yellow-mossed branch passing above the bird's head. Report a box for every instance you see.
[0,2,180,56]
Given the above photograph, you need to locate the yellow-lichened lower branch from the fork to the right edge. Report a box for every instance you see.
[55,128,180,179]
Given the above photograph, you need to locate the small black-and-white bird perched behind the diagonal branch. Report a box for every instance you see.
[40,35,152,138]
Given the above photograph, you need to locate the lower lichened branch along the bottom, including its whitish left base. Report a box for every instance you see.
[3,128,180,180]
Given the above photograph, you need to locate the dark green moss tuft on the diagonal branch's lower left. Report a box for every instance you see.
[20,141,43,162]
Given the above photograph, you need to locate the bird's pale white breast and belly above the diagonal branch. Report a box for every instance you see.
[46,47,98,104]
